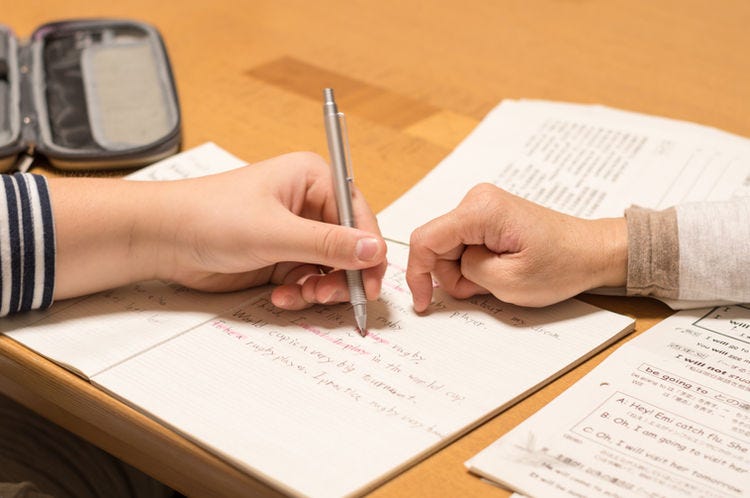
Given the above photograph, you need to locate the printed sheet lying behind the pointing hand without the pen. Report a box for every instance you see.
[378,100,750,242]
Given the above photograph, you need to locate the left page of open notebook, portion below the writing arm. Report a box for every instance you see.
[2,281,254,379]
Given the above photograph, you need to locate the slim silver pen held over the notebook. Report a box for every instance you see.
[323,88,367,337]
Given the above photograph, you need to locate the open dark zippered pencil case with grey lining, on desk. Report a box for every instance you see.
[0,19,181,171]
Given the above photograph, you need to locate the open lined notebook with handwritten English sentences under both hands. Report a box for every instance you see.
[1,144,634,496]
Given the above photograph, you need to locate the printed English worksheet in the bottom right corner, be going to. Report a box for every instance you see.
[467,305,750,498]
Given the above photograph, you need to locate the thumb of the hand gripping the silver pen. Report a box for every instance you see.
[269,216,386,270]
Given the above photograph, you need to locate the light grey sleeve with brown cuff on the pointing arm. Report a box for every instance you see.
[625,197,750,307]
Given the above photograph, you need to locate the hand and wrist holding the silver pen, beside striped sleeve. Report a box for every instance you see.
[50,153,386,309]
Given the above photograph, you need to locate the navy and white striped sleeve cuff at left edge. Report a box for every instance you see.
[0,173,55,316]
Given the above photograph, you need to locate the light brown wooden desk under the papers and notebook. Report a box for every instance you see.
[0,0,750,497]
